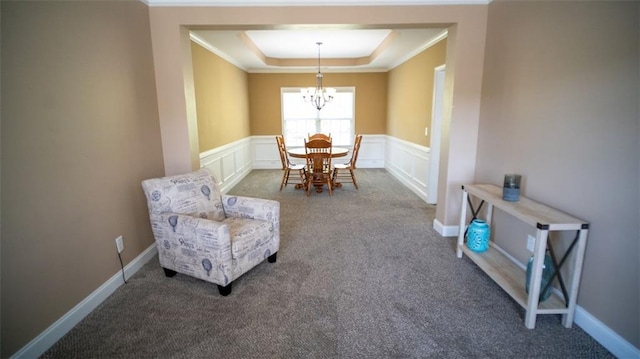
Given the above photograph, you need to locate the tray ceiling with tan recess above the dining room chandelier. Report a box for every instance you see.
[191,26,447,73]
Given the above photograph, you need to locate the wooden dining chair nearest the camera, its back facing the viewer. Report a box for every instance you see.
[304,139,333,196]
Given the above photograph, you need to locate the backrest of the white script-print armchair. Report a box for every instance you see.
[142,168,225,221]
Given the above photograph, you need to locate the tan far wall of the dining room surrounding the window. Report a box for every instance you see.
[249,72,387,135]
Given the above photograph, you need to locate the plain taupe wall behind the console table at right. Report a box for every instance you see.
[476,1,640,348]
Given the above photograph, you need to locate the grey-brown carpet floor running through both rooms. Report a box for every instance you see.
[42,169,613,358]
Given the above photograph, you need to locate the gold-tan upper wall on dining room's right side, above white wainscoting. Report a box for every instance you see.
[387,40,447,147]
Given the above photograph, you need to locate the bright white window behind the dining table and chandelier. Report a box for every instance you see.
[281,87,355,147]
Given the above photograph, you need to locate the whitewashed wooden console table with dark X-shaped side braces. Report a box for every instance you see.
[456,184,589,329]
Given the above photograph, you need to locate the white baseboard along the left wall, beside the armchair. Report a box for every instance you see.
[11,243,158,358]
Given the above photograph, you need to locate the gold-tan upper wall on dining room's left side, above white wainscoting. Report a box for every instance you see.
[191,42,250,152]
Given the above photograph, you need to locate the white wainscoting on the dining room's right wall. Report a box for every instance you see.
[384,136,430,201]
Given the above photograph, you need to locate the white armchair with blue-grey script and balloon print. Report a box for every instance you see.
[142,169,280,296]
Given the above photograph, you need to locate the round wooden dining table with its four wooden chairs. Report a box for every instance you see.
[276,133,362,196]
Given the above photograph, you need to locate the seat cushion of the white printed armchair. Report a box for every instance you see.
[222,217,273,259]
